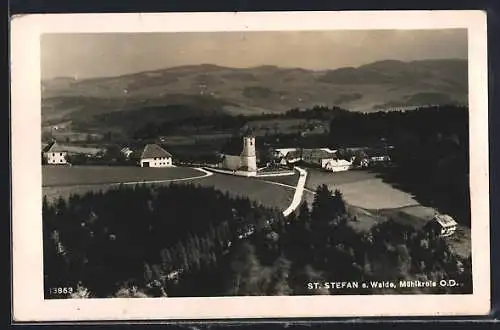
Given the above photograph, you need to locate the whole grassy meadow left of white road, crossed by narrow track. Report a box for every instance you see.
[42,166,295,210]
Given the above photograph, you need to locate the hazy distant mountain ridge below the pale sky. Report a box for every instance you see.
[42,59,468,125]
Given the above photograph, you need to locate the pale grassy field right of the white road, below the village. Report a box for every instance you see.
[306,169,418,209]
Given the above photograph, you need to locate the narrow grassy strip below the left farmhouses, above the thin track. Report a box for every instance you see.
[42,166,203,187]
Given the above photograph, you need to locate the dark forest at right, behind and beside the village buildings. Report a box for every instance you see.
[328,105,471,226]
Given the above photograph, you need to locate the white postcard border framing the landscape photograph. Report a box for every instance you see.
[11,11,490,322]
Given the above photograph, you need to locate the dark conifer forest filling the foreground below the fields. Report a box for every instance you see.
[43,184,472,298]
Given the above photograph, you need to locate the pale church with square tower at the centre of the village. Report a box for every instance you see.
[221,135,257,174]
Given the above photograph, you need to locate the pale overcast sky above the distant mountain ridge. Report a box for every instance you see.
[41,29,467,79]
